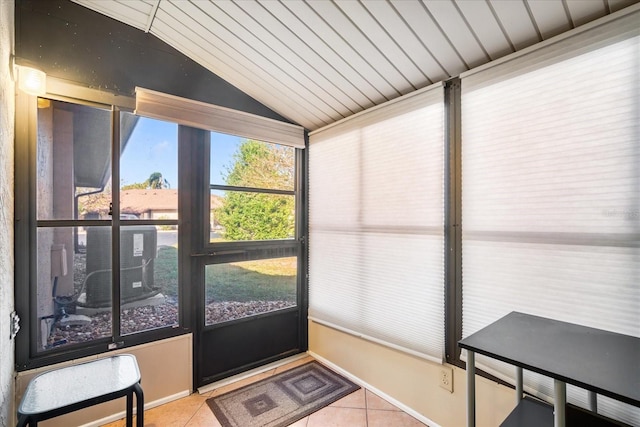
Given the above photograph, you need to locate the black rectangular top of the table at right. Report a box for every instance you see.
[458,312,640,406]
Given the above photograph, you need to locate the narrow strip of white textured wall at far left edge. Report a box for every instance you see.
[0,0,15,426]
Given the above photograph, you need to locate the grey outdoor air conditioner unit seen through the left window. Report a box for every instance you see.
[85,225,157,307]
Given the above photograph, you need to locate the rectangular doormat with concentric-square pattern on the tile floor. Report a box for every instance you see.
[207,361,360,427]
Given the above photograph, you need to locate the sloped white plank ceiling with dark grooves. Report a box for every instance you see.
[74,0,639,130]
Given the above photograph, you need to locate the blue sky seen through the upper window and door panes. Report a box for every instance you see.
[120,117,244,188]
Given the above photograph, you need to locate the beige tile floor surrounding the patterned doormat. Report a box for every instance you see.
[103,357,425,427]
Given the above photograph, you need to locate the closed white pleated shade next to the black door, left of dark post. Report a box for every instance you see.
[309,85,444,362]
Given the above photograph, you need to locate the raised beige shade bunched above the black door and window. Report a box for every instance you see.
[135,87,304,148]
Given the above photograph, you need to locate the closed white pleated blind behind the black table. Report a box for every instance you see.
[462,12,640,425]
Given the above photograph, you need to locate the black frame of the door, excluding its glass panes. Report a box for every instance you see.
[185,126,308,389]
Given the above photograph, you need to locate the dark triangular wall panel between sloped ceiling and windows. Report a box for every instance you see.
[16,0,286,121]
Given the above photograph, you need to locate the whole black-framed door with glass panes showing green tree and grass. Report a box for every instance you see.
[183,126,307,387]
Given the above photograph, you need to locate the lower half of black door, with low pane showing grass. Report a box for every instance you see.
[195,246,306,387]
